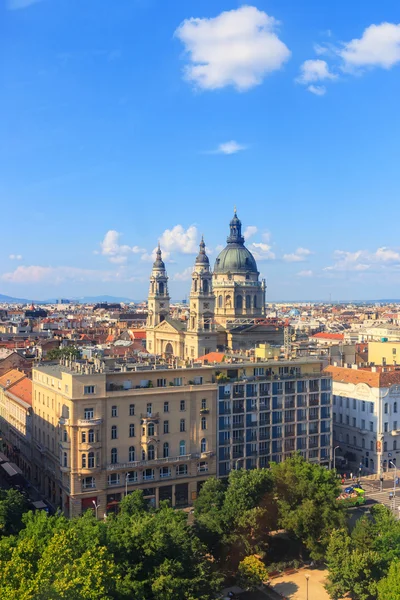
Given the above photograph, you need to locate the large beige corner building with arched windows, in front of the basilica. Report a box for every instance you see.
[33,361,217,517]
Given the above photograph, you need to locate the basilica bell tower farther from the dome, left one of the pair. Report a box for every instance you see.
[146,244,170,354]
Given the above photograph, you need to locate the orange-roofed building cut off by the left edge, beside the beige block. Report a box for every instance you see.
[0,369,32,479]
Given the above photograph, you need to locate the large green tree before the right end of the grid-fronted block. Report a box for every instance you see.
[272,454,345,560]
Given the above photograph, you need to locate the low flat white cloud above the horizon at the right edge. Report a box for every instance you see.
[324,246,400,272]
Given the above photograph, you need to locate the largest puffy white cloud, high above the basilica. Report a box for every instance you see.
[175,6,291,91]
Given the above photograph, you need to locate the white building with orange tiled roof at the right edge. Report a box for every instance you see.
[325,365,400,473]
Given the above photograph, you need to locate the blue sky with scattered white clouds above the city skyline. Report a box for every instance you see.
[0,0,400,301]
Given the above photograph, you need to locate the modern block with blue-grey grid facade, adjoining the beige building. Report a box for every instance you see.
[217,358,332,477]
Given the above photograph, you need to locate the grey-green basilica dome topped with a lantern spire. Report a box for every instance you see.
[214,211,258,275]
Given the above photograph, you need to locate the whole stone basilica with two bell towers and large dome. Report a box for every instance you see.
[146,210,276,359]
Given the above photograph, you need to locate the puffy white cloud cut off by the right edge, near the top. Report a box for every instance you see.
[338,23,400,72]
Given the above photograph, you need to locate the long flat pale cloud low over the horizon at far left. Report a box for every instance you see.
[1,265,124,284]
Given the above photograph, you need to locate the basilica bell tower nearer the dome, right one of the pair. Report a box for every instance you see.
[185,238,217,359]
